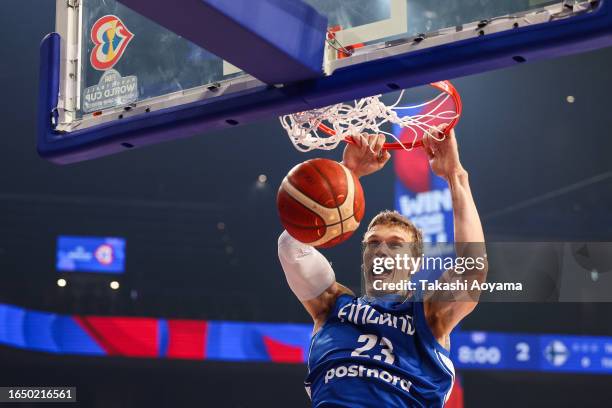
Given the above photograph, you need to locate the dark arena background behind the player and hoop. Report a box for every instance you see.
[0,0,612,407]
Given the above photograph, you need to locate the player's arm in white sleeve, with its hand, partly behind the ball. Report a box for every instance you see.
[278,135,390,331]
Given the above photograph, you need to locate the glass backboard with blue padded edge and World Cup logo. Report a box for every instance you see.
[38,0,612,164]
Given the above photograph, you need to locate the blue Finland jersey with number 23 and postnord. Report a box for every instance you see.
[305,295,455,408]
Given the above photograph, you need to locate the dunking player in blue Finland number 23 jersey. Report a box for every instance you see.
[278,128,487,408]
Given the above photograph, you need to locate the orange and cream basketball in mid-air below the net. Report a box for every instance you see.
[276,159,365,248]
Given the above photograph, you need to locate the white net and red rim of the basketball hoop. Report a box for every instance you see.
[280,81,462,152]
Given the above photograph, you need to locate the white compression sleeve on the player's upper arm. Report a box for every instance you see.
[278,231,336,301]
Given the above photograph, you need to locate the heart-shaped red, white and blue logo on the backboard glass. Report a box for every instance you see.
[90,15,134,71]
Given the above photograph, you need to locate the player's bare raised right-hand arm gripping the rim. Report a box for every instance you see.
[424,131,488,340]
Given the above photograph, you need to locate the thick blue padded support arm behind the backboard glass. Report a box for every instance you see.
[120,0,327,84]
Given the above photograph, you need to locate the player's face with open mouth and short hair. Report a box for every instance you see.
[363,225,415,296]
